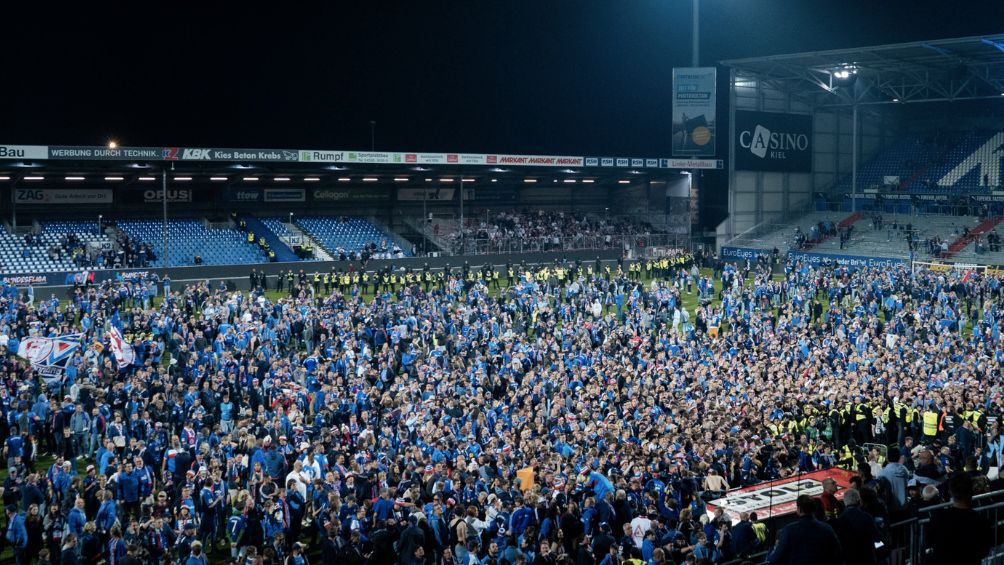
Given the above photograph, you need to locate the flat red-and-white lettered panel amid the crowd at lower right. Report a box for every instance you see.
[708,469,854,523]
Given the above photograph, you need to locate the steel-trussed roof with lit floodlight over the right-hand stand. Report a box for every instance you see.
[721,34,1004,107]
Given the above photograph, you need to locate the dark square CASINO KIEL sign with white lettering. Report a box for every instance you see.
[736,111,812,173]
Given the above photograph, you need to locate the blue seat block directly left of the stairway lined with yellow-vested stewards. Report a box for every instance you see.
[117,219,266,267]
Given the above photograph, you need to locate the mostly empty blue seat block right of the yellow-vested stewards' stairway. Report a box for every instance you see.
[294,216,411,258]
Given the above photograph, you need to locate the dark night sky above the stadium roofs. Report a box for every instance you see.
[0,0,1004,157]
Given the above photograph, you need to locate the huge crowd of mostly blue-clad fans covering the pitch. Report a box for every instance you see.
[0,252,1004,565]
